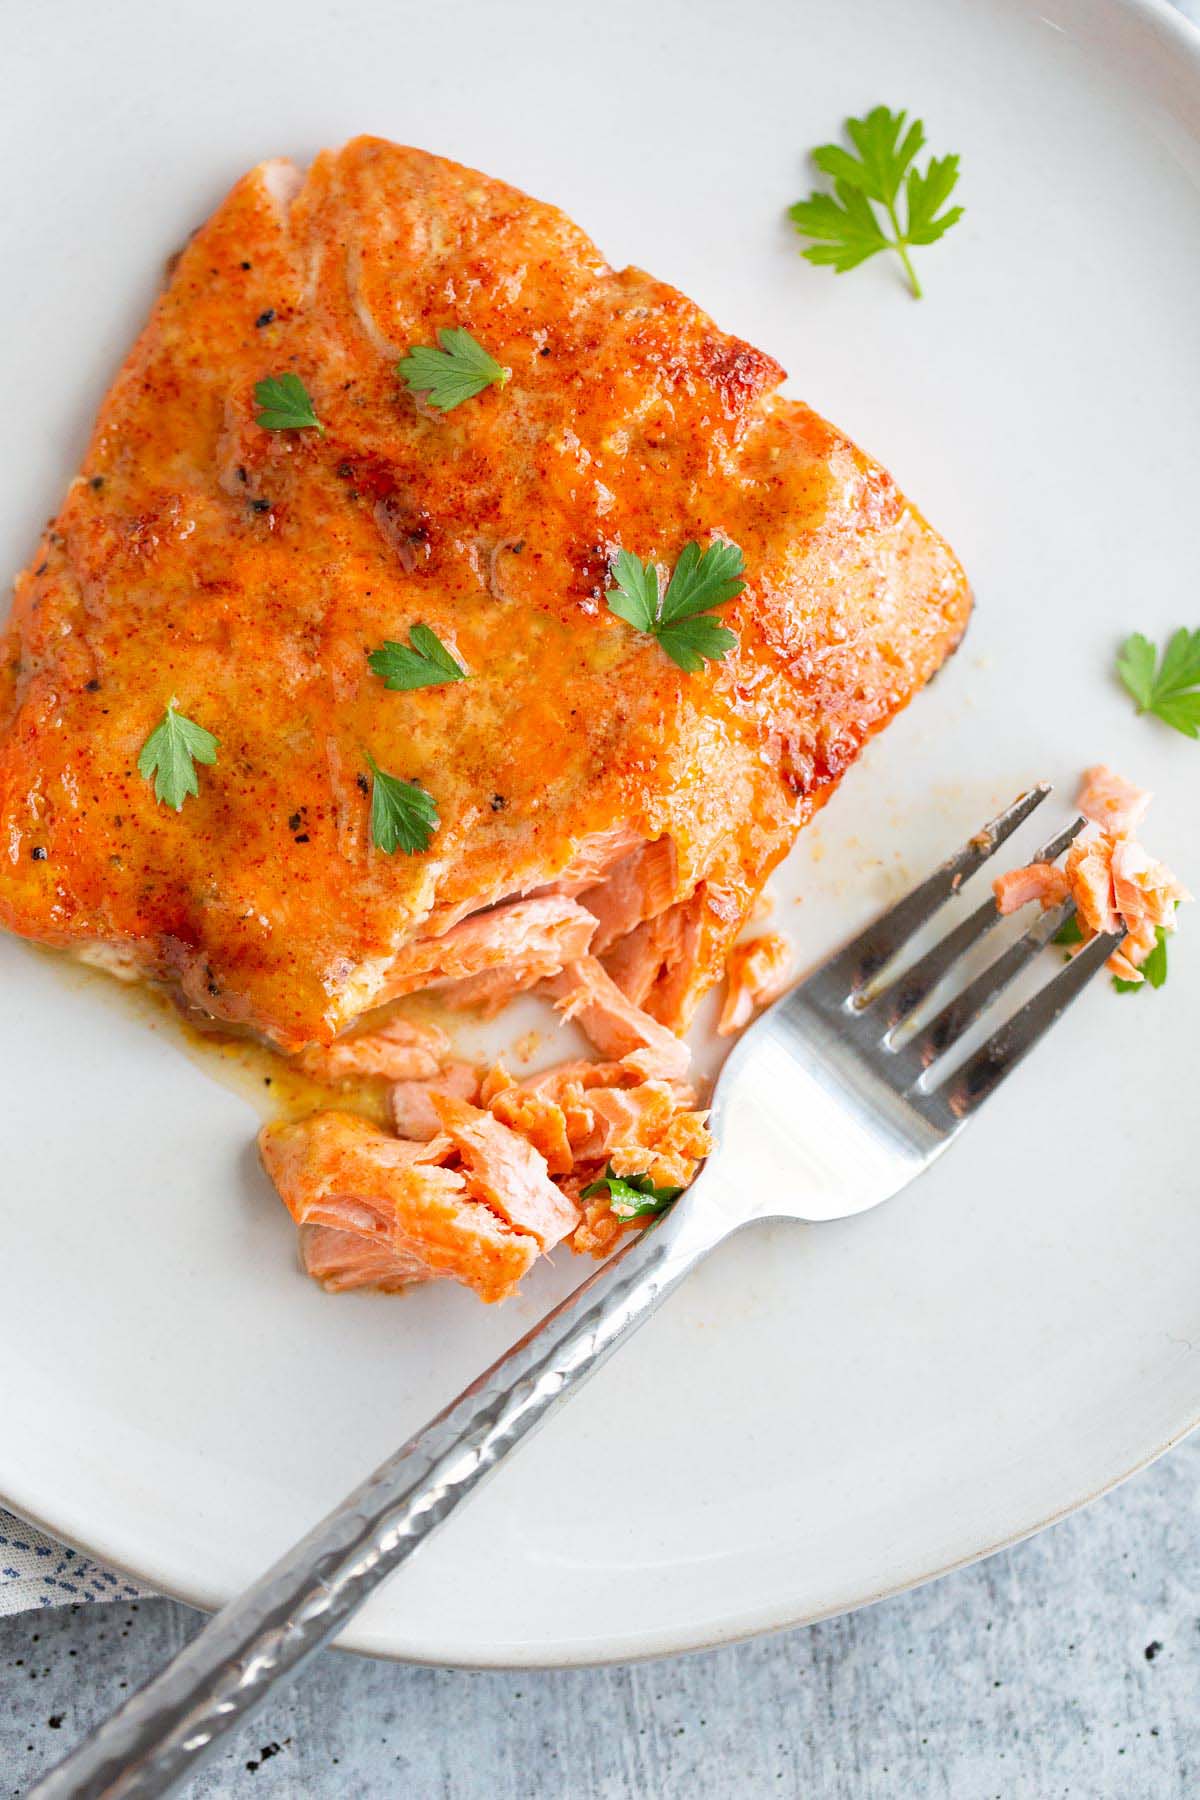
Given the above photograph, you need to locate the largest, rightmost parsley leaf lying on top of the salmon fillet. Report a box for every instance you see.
[604,542,745,675]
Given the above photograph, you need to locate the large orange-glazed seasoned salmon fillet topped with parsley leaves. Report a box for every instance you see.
[0,137,970,1051]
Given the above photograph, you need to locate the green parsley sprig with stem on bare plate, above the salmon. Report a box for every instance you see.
[788,106,963,301]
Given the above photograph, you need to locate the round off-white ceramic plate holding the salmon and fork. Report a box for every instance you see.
[0,0,1200,1663]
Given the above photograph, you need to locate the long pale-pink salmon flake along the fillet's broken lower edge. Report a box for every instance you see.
[379,895,596,1004]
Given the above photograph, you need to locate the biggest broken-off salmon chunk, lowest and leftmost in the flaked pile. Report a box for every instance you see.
[259,1112,540,1301]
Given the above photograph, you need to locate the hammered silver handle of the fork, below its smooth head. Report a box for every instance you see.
[29,1170,727,1800]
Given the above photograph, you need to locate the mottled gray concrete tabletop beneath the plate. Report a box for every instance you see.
[0,1436,1200,1800]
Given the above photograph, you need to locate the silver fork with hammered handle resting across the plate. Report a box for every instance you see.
[31,785,1115,1800]
